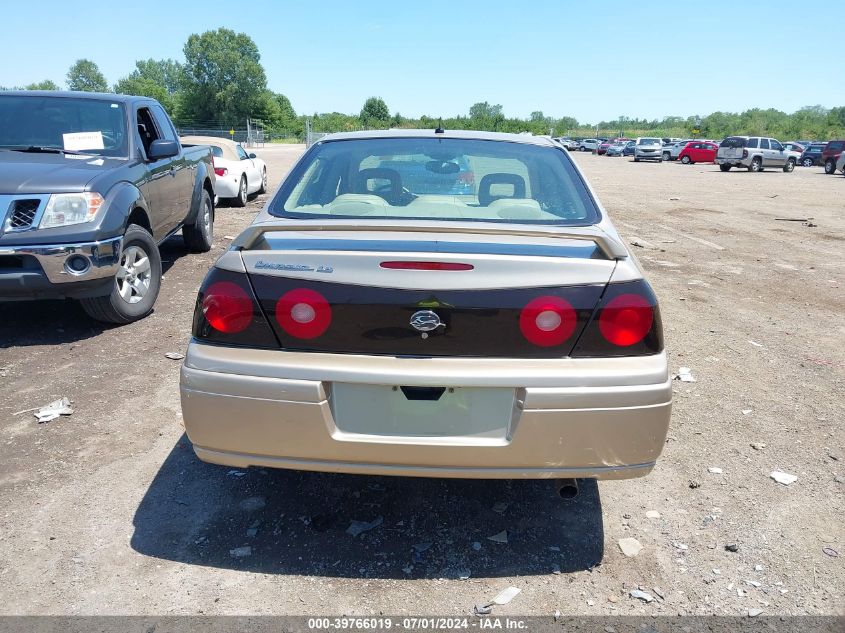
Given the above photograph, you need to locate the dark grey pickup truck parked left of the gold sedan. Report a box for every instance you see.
[0,91,214,323]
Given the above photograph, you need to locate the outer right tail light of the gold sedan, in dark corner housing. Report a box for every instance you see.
[572,280,663,357]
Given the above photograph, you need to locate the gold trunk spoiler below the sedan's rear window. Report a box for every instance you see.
[232,218,628,259]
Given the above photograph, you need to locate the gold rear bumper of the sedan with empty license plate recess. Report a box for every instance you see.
[181,342,672,479]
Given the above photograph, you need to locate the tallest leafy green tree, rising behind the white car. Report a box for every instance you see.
[179,28,267,125]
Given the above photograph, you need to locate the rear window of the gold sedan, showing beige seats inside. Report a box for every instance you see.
[269,137,599,225]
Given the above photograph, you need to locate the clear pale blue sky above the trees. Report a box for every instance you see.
[0,0,845,123]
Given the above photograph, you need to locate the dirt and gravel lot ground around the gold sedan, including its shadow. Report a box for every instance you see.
[0,146,845,615]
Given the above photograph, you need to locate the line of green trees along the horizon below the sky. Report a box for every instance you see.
[0,28,845,140]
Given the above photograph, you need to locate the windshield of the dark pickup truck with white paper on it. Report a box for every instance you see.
[0,95,128,156]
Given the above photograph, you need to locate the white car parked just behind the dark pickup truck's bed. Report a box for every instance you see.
[182,136,267,207]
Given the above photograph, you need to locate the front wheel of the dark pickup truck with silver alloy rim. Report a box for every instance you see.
[80,224,161,323]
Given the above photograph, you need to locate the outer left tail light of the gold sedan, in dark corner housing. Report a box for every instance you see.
[193,268,279,348]
